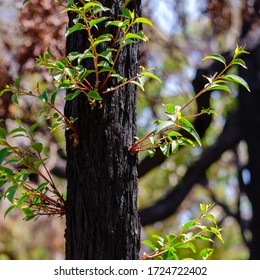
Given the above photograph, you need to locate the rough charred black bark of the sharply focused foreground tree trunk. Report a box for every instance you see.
[65,0,141,260]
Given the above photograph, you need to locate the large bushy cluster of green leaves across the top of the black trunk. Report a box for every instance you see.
[36,0,160,107]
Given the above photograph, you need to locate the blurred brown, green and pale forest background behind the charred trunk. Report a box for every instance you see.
[0,0,260,259]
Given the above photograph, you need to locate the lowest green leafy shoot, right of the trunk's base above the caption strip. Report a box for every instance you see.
[141,204,224,260]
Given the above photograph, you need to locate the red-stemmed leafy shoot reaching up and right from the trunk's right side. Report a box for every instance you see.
[130,46,250,157]
